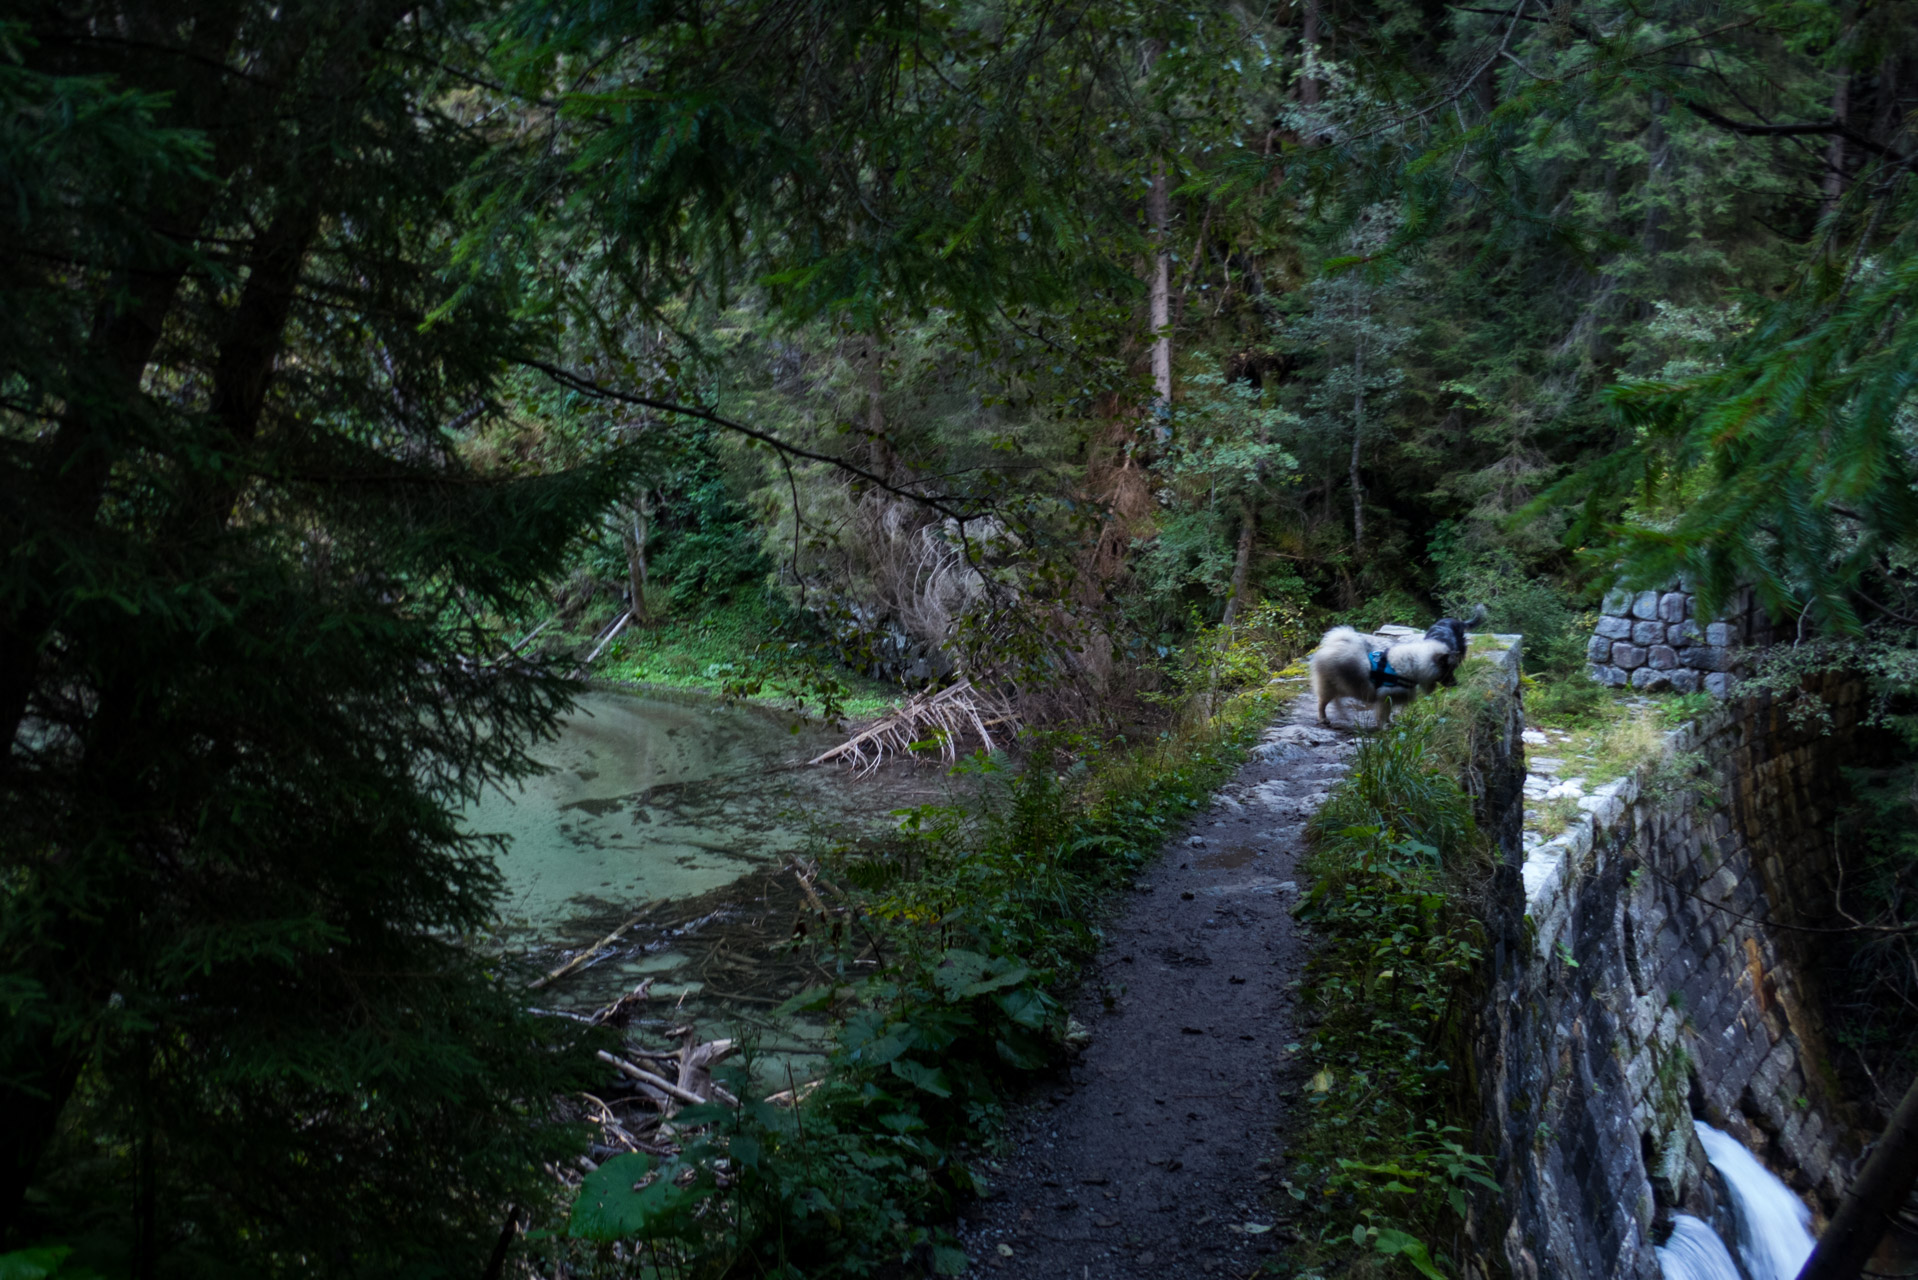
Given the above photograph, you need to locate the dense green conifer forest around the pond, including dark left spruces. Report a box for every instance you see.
[0,0,1918,1274]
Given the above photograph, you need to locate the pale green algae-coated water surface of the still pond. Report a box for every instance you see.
[466,689,940,1004]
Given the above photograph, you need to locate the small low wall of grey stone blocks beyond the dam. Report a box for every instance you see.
[1584,583,1770,699]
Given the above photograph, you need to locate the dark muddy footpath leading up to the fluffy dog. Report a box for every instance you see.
[961,697,1356,1280]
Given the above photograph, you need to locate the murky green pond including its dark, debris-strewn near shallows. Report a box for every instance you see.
[466,691,946,1074]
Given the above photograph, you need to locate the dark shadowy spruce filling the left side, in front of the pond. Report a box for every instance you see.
[0,0,637,1276]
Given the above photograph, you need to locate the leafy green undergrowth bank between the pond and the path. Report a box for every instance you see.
[535,621,1291,1280]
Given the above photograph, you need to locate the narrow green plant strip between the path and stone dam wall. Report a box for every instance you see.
[1283,658,1509,1276]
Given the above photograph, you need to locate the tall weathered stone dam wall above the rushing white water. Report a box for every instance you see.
[1469,683,1862,1280]
